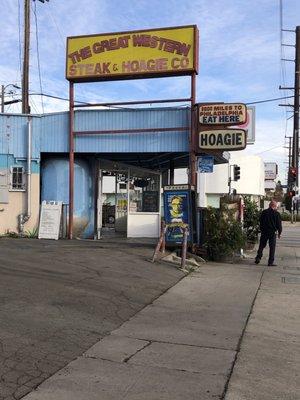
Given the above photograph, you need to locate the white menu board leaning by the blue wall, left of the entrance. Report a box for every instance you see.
[38,201,62,240]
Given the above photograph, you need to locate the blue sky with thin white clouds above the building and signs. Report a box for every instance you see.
[0,0,300,181]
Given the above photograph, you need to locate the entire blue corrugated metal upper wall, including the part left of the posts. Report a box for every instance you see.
[0,108,190,159]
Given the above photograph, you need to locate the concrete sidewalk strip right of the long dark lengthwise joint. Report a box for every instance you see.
[225,247,300,400]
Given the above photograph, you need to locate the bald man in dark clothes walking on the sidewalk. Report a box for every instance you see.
[255,200,282,267]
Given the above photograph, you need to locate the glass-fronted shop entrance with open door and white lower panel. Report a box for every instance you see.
[97,160,161,239]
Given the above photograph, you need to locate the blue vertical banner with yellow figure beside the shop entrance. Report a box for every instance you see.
[164,190,193,244]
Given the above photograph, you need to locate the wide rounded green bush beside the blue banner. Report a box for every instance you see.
[204,208,245,261]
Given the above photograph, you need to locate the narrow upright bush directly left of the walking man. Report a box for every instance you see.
[243,196,261,247]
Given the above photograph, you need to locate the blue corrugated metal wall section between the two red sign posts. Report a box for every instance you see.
[75,108,190,153]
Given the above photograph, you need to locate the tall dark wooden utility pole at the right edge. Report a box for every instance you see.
[292,26,300,193]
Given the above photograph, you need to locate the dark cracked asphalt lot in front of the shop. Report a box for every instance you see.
[0,238,183,400]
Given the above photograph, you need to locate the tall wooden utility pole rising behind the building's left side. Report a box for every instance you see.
[22,0,31,114]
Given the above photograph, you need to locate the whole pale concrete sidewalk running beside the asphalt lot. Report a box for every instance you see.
[25,249,300,400]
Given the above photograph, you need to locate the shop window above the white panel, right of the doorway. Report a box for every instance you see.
[129,169,160,213]
